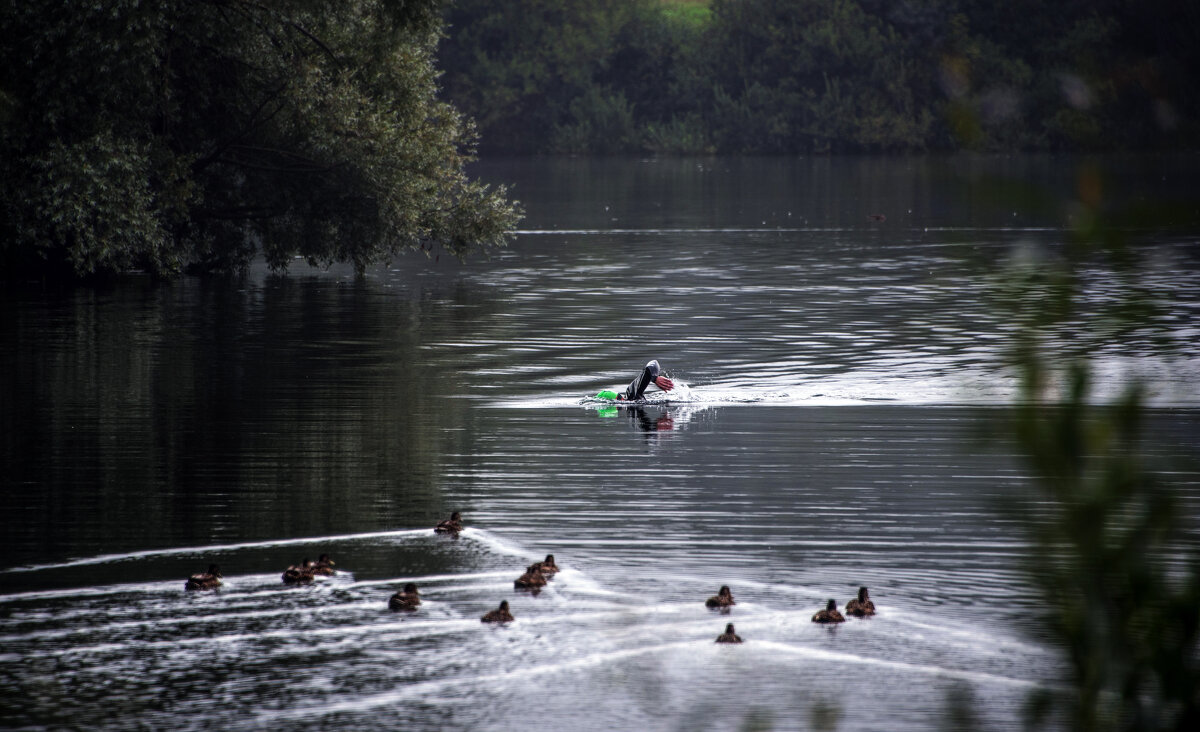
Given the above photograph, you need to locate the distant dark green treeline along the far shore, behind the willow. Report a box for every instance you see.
[439,0,1200,154]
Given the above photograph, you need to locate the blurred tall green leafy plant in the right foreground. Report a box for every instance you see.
[1003,169,1200,731]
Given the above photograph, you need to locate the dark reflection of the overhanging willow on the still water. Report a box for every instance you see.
[0,273,491,562]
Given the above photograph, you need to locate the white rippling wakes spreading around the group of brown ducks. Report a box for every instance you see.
[0,527,1065,728]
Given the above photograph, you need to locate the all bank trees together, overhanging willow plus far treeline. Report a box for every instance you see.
[0,0,1200,282]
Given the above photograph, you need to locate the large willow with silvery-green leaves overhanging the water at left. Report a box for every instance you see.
[0,0,518,276]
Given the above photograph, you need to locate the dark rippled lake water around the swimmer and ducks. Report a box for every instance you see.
[0,156,1200,730]
